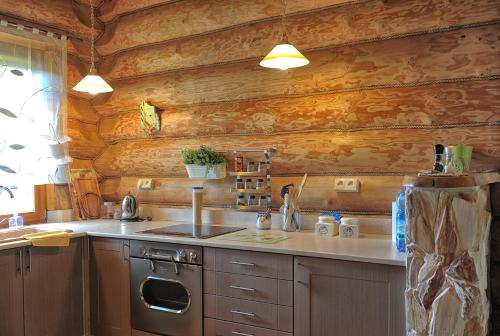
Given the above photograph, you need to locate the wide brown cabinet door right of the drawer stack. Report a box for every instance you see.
[294,257,405,336]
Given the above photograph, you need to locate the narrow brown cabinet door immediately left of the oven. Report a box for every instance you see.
[90,238,132,336]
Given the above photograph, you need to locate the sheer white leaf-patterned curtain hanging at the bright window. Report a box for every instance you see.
[0,26,71,185]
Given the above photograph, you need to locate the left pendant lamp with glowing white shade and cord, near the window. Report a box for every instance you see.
[73,0,113,95]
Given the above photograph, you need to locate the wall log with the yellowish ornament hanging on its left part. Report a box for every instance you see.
[99,80,500,142]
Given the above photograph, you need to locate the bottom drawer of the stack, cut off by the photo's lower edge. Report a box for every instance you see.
[203,318,292,336]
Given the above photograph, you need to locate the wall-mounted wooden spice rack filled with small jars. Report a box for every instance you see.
[229,148,276,211]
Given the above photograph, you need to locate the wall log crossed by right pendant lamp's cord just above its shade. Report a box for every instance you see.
[99,0,498,79]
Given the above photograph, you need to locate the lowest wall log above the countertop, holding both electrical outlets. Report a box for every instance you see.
[100,176,403,213]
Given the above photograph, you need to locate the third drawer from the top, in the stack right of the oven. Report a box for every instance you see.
[204,294,293,332]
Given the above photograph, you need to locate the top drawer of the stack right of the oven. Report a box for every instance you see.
[207,249,293,280]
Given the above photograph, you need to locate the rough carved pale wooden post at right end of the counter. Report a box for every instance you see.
[405,175,498,336]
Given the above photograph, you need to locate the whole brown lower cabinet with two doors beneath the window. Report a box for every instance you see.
[0,239,84,336]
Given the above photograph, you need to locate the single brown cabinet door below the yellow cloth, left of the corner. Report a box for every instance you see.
[23,239,83,336]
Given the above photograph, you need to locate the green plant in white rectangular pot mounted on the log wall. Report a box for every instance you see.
[182,145,226,180]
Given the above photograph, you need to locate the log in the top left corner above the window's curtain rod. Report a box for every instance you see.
[0,0,90,39]
